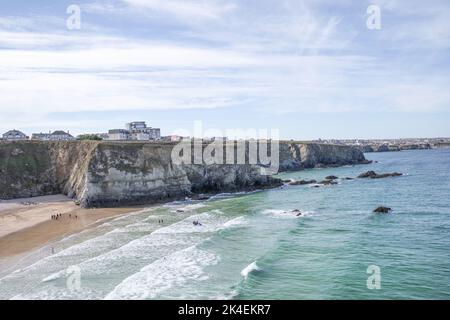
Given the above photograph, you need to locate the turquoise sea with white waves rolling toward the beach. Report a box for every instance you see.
[0,149,450,299]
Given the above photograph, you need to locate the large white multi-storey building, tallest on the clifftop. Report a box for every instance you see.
[108,121,161,141]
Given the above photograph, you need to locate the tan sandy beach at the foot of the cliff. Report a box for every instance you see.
[0,195,141,265]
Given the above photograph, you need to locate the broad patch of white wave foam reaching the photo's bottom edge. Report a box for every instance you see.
[105,246,218,299]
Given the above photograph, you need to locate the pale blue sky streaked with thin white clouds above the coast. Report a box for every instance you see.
[0,0,450,140]
